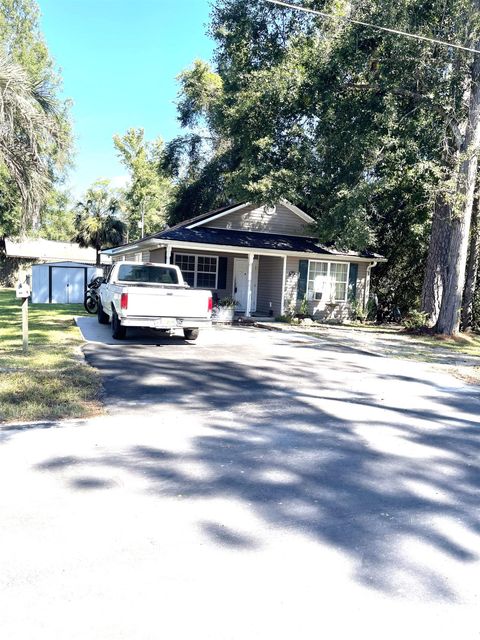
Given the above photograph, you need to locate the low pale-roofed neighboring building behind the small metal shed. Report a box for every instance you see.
[0,238,111,287]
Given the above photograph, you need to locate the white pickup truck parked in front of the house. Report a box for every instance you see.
[98,262,212,340]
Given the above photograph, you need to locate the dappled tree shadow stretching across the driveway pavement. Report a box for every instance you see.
[40,347,480,601]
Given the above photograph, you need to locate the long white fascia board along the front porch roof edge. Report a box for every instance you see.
[156,239,380,263]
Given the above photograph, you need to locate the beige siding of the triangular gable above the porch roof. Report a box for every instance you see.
[202,204,310,236]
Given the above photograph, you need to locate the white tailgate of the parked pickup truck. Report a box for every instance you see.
[123,286,210,318]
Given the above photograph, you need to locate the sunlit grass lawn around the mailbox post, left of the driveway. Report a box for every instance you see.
[0,289,101,422]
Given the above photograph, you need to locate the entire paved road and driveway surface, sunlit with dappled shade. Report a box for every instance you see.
[0,320,480,640]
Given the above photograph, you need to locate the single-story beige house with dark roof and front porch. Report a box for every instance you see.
[103,200,385,320]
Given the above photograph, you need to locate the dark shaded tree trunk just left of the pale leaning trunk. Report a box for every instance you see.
[422,193,451,327]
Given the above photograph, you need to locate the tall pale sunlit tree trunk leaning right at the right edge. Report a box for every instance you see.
[436,46,480,335]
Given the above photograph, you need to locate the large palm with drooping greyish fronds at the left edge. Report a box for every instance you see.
[0,55,67,231]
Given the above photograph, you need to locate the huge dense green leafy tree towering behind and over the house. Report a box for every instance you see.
[168,0,476,331]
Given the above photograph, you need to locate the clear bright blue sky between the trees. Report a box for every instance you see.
[38,0,213,197]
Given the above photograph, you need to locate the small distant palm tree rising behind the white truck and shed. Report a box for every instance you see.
[73,180,126,266]
